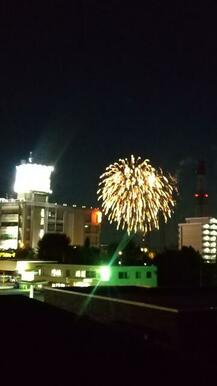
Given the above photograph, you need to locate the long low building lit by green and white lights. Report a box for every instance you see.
[0,260,157,288]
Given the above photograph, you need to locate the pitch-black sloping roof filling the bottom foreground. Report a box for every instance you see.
[0,295,217,385]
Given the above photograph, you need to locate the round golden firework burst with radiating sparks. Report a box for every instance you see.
[97,155,177,234]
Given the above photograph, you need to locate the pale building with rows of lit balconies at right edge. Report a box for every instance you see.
[179,217,217,262]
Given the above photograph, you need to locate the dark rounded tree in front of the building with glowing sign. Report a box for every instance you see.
[38,233,70,263]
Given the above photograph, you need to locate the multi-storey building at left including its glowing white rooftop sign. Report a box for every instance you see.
[0,157,102,250]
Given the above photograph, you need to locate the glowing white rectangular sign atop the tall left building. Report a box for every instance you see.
[14,163,54,193]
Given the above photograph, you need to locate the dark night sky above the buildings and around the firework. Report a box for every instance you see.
[0,0,217,244]
